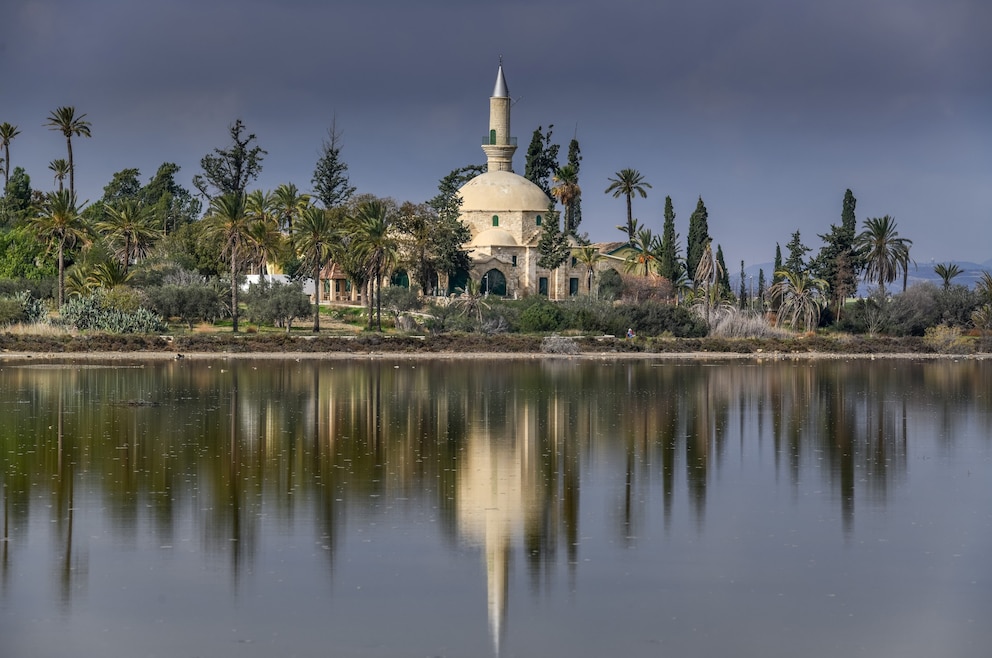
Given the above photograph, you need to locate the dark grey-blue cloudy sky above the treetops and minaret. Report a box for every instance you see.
[0,0,992,272]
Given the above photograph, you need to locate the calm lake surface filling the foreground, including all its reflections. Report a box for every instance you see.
[0,358,992,658]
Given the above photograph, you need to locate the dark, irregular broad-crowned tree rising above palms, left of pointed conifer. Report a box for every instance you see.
[193,119,268,199]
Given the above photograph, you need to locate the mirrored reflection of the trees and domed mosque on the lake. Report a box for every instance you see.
[0,360,992,653]
